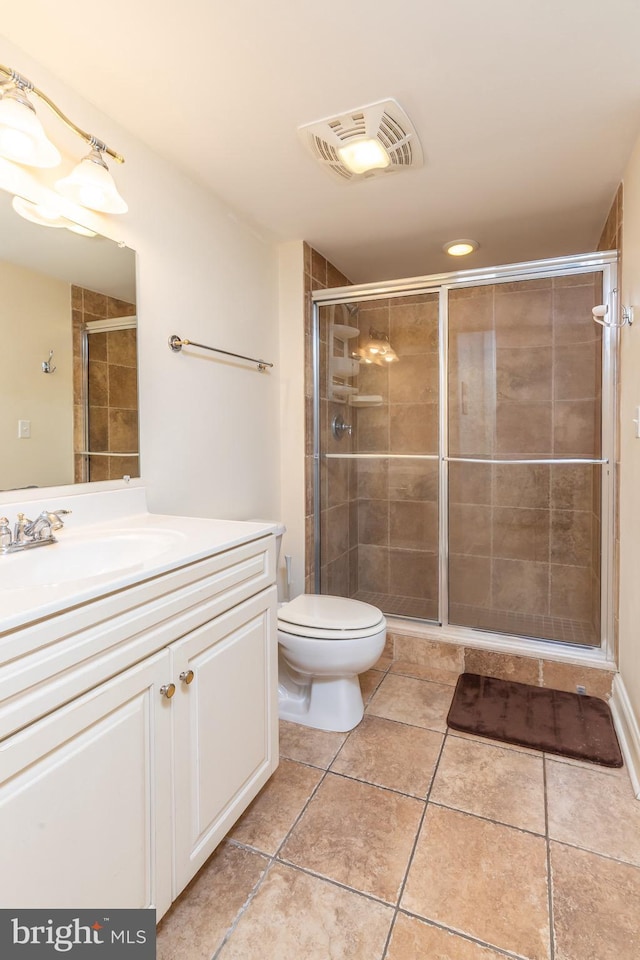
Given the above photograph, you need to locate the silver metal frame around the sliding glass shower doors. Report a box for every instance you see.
[311,250,619,662]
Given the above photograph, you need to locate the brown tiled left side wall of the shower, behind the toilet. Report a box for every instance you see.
[304,243,358,596]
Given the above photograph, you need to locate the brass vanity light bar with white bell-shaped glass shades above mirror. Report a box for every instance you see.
[0,64,128,214]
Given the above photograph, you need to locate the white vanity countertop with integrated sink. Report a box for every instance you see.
[0,490,274,637]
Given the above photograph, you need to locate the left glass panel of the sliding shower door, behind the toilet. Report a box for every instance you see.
[319,293,440,620]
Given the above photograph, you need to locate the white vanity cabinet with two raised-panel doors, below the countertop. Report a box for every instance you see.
[0,536,278,918]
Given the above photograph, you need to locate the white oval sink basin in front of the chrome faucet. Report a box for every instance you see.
[0,529,185,595]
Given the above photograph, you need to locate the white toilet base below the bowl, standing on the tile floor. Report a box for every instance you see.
[278,661,364,733]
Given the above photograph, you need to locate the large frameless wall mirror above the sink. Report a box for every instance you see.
[0,193,140,491]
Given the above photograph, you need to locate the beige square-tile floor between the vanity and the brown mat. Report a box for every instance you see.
[157,659,640,960]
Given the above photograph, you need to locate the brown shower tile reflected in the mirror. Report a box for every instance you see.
[71,286,140,482]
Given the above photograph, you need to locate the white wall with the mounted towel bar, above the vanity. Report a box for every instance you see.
[0,37,280,519]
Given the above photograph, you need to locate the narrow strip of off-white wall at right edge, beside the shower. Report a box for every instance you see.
[619,138,640,736]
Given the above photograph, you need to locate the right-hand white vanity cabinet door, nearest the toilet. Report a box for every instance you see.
[170,587,278,896]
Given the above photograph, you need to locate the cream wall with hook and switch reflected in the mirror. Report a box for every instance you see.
[0,261,73,490]
